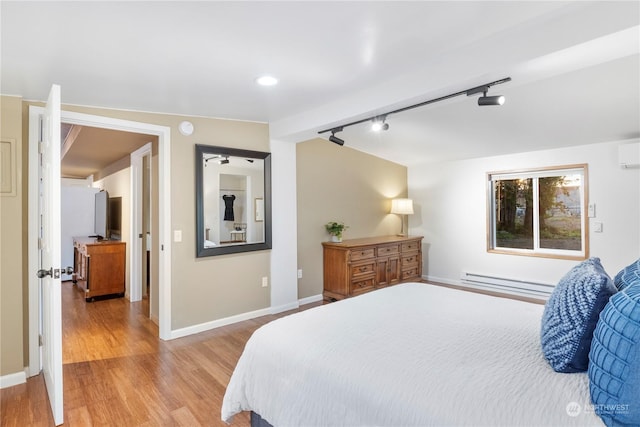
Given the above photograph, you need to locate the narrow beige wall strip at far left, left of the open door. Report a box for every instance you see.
[0,96,27,376]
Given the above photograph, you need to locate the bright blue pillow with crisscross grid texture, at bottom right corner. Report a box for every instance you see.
[589,279,640,427]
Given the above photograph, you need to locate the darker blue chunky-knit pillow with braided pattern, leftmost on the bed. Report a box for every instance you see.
[540,258,617,372]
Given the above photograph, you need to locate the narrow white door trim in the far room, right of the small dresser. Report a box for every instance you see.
[129,143,151,301]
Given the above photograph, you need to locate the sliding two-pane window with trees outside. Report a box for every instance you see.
[487,164,589,259]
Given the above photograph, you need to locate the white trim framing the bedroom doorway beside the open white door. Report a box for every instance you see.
[28,106,171,376]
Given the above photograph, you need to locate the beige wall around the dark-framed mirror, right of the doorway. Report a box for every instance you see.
[55,106,270,330]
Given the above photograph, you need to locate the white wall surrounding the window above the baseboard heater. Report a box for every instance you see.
[408,141,640,284]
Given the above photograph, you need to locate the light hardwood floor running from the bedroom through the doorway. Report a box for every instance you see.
[0,282,320,427]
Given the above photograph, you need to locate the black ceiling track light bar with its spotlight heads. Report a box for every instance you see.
[318,77,511,145]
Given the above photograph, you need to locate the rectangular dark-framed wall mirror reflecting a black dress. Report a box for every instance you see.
[196,145,271,257]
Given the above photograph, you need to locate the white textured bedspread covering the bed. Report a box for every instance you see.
[222,283,604,427]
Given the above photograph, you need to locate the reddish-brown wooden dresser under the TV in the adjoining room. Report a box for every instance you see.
[72,237,126,301]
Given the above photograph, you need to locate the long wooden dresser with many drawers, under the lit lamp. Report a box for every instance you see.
[322,236,423,301]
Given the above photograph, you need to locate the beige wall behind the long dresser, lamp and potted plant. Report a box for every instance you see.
[296,139,407,298]
